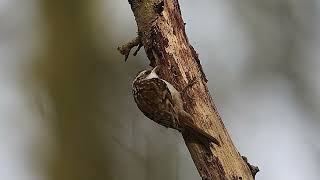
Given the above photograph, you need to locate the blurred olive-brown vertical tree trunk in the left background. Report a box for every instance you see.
[36,0,112,180]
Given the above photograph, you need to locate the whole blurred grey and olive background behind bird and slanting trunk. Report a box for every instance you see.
[0,0,320,180]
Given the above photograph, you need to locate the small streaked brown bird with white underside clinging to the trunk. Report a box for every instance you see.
[132,65,220,149]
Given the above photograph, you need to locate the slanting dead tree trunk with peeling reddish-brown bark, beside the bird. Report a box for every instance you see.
[120,0,254,180]
